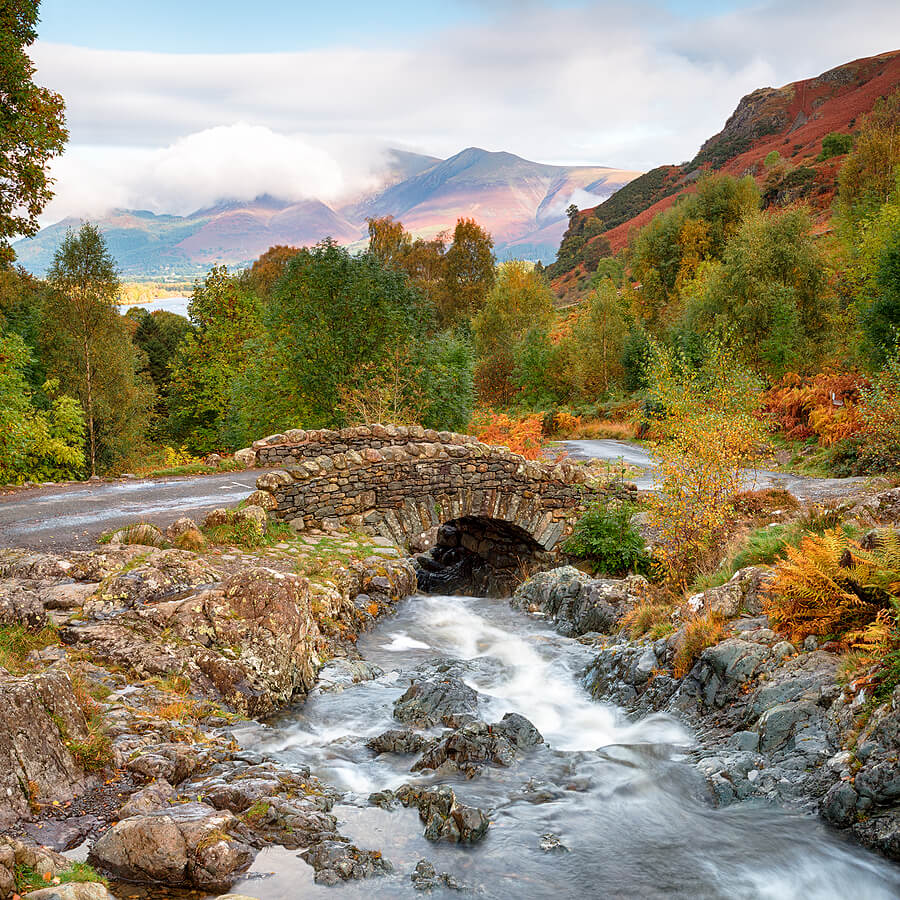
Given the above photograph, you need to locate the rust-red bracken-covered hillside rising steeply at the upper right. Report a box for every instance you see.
[549,51,900,300]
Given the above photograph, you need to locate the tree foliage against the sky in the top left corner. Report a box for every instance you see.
[0,0,68,265]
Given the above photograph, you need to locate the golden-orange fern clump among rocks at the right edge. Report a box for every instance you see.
[763,529,900,641]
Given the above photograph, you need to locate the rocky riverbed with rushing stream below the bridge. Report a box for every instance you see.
[0,495,900,900]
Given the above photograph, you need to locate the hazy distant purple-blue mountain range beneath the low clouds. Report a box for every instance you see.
[15,148,639,279]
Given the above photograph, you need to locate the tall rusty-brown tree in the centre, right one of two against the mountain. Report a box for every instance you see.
[437,219,495,326]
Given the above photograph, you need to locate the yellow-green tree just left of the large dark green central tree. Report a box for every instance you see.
[168,266,264,453]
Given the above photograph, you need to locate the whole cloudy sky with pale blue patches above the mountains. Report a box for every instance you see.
[31,0,900,224]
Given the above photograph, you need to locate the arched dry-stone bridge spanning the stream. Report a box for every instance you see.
[248,425,596,588]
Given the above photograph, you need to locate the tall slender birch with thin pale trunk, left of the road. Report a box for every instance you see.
[43,224,152,475]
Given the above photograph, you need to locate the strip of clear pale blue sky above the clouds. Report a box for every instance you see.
[41,0,752,53]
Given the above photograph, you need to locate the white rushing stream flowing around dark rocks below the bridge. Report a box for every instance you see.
[227,596,900,900]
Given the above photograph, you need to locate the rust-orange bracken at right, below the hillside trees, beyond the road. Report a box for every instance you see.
[763,372,866,447]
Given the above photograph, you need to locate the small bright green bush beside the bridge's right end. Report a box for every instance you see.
[563,502,650,575]
